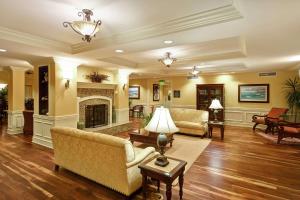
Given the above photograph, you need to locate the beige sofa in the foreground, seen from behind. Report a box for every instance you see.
[51,127,156,196]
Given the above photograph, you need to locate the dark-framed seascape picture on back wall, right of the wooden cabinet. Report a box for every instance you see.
[239,84,269,103]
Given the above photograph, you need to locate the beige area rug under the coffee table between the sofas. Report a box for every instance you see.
[134,134,211,185]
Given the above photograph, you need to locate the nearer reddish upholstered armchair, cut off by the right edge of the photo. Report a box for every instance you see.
[277,122,300,144]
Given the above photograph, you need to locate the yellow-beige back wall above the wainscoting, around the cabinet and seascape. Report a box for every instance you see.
[130,71,298,109]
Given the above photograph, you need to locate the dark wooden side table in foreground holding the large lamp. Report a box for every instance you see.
[139,157,187,200]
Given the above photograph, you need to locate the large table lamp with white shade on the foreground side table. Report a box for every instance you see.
[145,106,178,167]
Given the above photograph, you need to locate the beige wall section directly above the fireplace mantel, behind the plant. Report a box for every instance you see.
[77,66,116,83]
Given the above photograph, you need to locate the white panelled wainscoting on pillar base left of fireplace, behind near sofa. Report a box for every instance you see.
[32,114,78,148]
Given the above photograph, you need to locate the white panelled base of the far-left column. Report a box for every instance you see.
[7,111,24,135]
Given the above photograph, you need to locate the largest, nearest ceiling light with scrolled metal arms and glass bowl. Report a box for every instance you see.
[63,9,101,42]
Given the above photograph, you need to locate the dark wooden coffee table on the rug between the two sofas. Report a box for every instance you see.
[129,130,174,147]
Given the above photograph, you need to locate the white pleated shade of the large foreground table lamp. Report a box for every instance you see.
[145,106,179,133]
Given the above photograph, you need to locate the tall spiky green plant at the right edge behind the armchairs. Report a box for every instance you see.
[283,77,300,122]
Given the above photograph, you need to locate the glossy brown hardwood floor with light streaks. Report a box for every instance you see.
[0,122,300,200]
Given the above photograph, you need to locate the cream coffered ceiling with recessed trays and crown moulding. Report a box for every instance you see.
[0,0,300,77]
